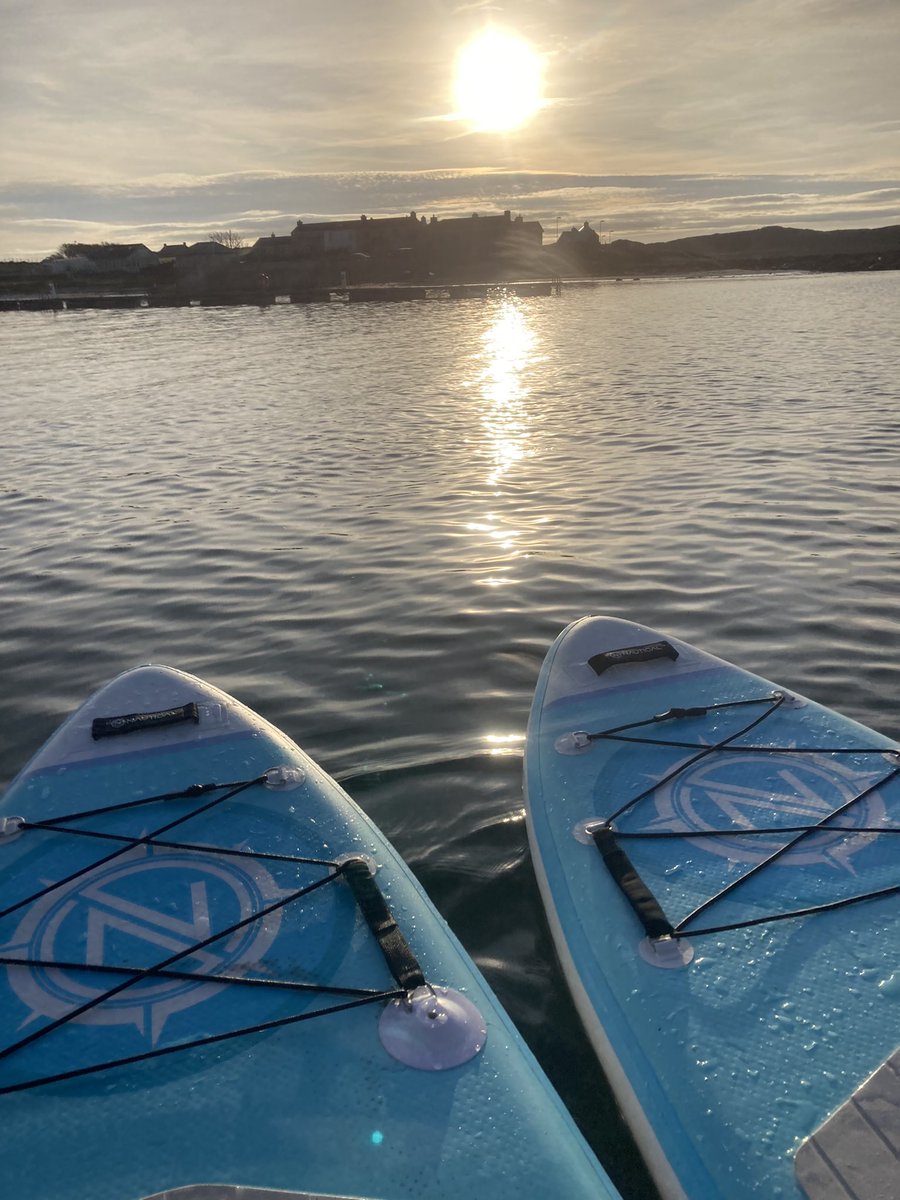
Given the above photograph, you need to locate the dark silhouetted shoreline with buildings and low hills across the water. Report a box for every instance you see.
[0,209,900,311]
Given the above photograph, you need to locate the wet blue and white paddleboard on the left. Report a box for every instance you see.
[0,667,614,1200]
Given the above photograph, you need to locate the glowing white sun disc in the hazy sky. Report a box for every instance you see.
[456,30,541,133]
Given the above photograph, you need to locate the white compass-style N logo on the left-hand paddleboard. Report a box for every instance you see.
[4,846,289,1045]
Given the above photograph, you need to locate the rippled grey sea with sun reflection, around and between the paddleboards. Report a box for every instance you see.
[0,274,900,1198]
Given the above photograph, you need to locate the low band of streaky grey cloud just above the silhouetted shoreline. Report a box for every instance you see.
[0,170,900,258]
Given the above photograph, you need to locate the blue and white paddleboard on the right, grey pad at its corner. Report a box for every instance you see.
[524,617,900,1200]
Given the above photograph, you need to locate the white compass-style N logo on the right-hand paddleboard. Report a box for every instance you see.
[649,752,884,874]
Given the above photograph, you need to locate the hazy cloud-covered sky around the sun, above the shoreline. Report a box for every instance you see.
[0,0,900,258]
